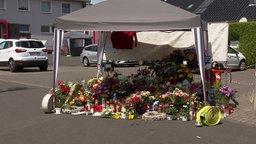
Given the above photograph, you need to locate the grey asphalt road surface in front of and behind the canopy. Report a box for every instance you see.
[0,55,256,144]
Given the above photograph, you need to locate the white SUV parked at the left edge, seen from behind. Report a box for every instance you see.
[0,39,48,72]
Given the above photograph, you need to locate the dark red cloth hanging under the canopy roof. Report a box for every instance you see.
[111,31,138,49]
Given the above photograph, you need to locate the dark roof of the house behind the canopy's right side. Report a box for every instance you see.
[166,0,256,22]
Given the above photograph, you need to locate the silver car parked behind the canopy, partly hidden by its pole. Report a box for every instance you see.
[80,44,139,67]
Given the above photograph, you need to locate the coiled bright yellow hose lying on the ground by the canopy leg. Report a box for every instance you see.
[196,106,221,126]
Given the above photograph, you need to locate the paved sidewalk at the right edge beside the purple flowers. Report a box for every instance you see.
[224,69,256,126]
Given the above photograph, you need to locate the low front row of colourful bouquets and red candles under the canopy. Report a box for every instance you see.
[53,77,204,119]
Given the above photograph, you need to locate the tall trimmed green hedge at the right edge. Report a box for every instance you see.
[229,22,256,66]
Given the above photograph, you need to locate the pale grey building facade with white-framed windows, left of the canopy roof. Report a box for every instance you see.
[0,0,90,40]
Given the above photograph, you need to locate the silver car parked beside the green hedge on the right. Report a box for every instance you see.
[225,47,246,70]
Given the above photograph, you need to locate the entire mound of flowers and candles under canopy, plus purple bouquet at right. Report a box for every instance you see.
[51,51,238,119]
